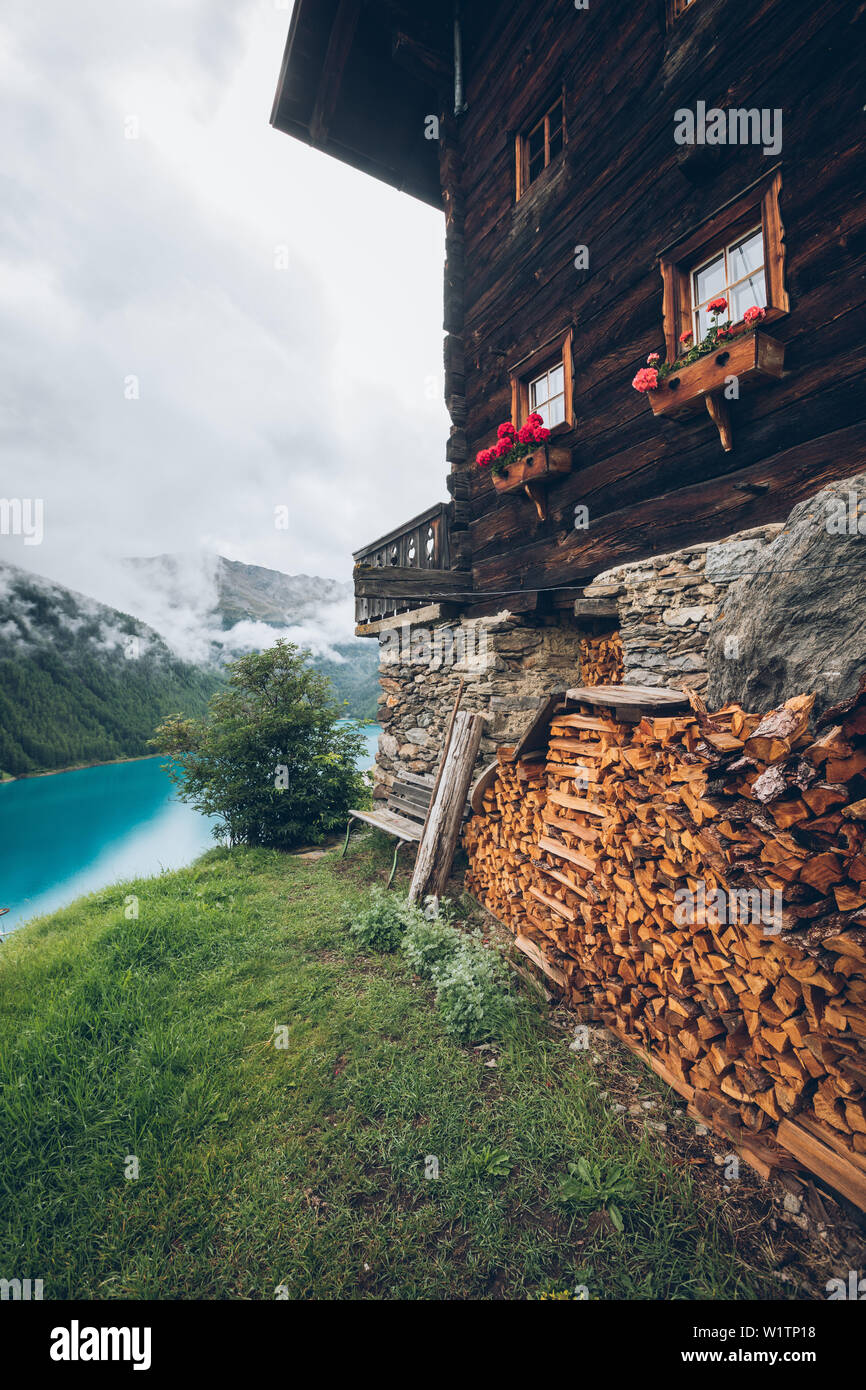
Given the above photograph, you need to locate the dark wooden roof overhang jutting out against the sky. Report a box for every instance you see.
[271,0,496,207]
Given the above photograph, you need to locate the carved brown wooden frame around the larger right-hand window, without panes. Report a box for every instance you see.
[659,170,790,363]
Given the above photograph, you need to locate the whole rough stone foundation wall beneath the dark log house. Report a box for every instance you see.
[373,524,783,799]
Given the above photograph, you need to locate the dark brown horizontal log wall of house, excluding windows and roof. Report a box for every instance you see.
[458,0,866,608]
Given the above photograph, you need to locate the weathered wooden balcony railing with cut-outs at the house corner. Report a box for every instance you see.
[354,502,473,628]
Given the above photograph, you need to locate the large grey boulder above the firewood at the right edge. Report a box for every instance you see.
[708,473,866,713]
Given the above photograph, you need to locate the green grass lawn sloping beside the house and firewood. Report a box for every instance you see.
[0,840,817,1300]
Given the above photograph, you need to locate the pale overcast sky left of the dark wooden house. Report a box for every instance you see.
[0,0,448,602]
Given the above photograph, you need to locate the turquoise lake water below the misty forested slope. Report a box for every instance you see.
[0,724,381,931]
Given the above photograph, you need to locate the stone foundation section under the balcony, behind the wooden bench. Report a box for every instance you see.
[373,613,584,799]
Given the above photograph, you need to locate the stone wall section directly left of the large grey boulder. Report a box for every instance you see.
[584,523,783,689]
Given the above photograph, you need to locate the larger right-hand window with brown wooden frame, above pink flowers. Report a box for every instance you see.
[659,171,788,361]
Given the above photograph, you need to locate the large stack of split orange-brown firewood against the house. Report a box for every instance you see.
[470,678,866,1173]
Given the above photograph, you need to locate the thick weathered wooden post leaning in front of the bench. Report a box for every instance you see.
[409,712,484,902]
